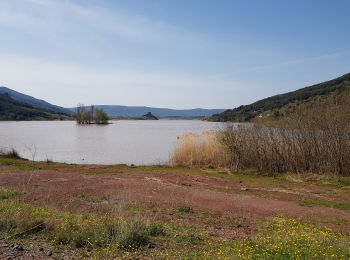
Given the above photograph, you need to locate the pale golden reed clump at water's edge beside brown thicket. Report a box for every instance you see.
[171,131,230,167]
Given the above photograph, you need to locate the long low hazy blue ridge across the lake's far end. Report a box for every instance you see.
[70,105,225,118]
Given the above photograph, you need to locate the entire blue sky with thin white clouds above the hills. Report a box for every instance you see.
[0,0,350,108]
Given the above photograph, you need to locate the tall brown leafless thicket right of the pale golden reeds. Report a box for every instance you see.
[222,92,350,175]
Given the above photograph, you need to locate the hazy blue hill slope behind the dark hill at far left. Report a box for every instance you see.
[0,86,72,114]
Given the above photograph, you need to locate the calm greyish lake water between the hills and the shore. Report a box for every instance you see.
[0,120,220,165]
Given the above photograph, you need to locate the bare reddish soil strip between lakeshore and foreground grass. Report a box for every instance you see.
[0,169,350,230]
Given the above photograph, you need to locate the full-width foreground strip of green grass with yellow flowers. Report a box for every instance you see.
[0,200,350,259]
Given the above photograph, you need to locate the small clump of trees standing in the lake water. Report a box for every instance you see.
[75,104,109,125]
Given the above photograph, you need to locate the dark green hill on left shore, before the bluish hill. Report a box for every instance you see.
[0,93,69,121]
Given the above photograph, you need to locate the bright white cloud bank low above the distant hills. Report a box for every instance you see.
[0,54,239,108]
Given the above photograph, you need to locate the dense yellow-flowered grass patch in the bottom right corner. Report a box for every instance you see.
[196,218,350,259]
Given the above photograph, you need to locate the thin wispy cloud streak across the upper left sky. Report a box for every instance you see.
[0,0,212,48]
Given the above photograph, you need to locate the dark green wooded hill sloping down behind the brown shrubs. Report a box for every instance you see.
[208,73,350,122]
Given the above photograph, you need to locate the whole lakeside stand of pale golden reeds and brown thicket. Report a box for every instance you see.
[172,91,350,176]
